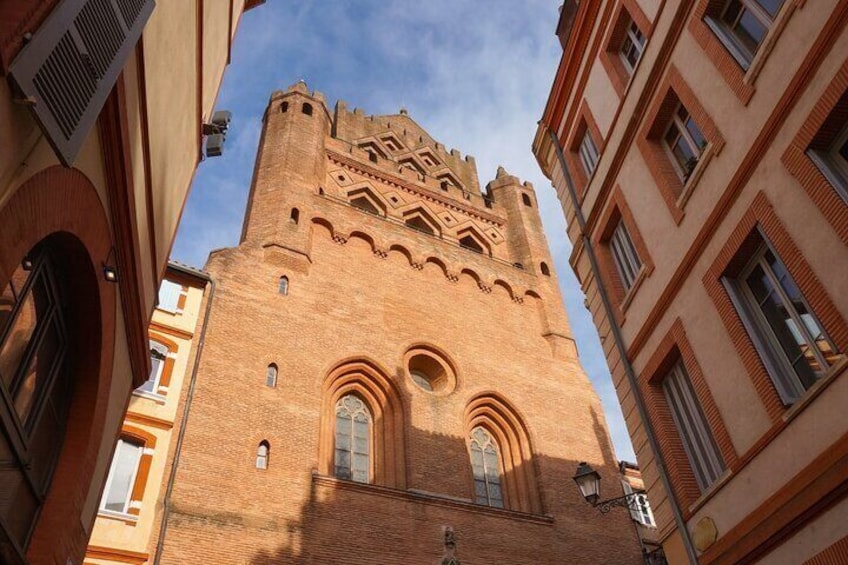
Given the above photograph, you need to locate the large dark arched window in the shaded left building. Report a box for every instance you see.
[0,242,72,554]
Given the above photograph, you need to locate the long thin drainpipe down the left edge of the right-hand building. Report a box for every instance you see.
[548,126,698,563]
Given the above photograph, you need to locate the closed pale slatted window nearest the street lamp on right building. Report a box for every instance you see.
[662,360,726,493]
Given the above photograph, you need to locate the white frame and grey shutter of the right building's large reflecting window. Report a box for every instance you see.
[722,240,838,406]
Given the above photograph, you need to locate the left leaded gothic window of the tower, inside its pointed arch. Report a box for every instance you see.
[334,394,371,483]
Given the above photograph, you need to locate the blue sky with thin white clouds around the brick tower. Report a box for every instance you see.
[172,0,635,461]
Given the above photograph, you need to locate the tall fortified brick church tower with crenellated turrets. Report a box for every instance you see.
[156,83,639,565]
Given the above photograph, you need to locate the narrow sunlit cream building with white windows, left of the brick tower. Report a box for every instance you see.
[85,262,209,565]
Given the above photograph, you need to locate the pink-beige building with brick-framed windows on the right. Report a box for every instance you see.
[533,0,848,563]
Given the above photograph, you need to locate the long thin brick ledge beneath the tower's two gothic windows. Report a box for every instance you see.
[312,471,554,526]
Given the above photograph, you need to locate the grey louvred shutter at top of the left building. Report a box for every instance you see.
[9,0,155,166]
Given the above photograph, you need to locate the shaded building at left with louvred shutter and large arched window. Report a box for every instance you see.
[0,0,261,564]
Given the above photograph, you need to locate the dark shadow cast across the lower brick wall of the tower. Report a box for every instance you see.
[235,412,641,565]
